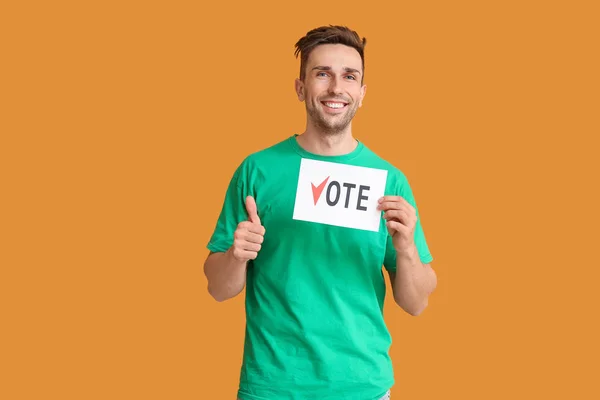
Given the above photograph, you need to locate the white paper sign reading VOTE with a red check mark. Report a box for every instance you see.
[293,158,387,232]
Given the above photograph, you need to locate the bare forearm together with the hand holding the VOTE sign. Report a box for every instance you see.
[379,196,437,316]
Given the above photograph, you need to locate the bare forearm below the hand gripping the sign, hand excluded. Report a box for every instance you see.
[394,246,437,315]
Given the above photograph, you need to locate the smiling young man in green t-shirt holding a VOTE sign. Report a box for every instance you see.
[204,26,436,400]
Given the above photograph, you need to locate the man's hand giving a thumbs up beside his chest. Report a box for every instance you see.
[232,196,265,262]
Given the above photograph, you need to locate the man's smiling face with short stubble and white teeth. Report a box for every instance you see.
[296,44,366,134]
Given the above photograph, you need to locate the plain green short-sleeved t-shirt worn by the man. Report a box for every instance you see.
[208,135,432,400]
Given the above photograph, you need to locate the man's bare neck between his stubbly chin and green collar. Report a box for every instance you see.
[296,126,358,156]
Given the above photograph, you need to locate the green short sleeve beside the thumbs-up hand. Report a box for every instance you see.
[207,164,250,253]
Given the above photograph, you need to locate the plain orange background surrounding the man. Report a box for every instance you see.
[0,1,600,400]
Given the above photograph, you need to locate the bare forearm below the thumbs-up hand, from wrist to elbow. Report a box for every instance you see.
[204,250,247,301]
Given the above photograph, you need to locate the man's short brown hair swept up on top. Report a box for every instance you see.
[294,25,367,81]
